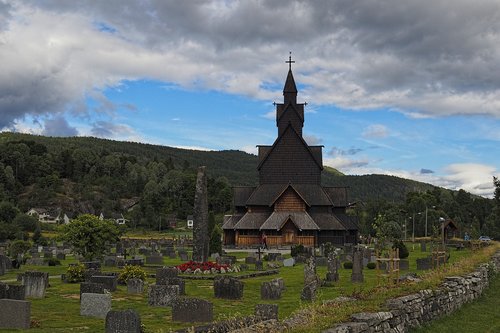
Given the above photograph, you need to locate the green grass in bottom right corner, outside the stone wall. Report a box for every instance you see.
[411,275,500,333]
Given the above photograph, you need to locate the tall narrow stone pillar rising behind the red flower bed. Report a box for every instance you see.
[193,166,210,262]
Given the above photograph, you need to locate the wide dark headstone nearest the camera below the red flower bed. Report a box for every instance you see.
[172,298,214,323]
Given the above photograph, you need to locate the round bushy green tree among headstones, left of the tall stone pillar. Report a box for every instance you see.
[61,214,123,260]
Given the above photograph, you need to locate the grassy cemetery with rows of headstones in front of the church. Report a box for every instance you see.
[0,235,500,332]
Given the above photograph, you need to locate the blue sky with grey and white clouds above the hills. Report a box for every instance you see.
[0,0,500,197]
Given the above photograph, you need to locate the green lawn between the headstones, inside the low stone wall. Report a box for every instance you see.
[0,242,500,333]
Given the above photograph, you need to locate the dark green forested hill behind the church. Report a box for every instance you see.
[0,132,433,216]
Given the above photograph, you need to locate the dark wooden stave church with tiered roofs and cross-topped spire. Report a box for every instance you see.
[222,57,358,247]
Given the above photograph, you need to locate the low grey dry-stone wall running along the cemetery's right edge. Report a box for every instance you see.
[323,253,500,333]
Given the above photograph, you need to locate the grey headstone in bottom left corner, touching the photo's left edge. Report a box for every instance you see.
[0,299,31,330]
